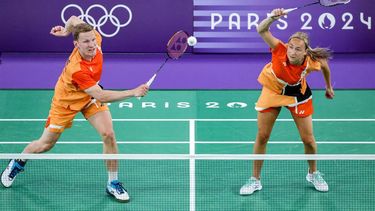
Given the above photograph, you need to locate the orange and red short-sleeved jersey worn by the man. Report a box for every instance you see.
[52,31,103,111]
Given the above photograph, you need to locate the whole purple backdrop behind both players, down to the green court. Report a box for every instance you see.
[0,0,375,89]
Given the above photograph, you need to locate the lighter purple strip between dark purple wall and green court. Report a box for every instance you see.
[0,54,375,89]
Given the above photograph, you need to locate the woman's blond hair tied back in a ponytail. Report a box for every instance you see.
[288,32,332,61]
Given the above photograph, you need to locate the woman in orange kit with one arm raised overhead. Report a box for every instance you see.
[240,9,334,195]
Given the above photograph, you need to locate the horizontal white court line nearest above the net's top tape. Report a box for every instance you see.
[0,140,375,144]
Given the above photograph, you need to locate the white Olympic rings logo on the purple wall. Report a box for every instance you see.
[61,4,133,37]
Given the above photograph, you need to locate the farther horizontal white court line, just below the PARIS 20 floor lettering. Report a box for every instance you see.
[0,119,375,122]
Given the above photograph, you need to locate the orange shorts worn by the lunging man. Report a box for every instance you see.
[45,101,109,133]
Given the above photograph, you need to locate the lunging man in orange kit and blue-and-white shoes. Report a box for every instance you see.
[1,16,148,201]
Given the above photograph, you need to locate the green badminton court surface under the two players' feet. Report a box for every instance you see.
[0,90,375,211]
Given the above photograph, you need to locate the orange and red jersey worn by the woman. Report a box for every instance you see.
[255,42,321,111]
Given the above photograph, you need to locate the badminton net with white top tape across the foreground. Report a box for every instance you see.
[0,154,375,211]
